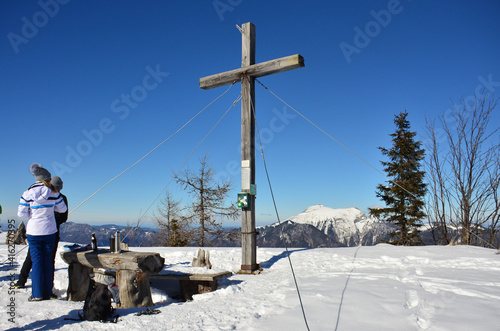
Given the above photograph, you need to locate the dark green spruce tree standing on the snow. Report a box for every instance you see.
[370,111,427,246]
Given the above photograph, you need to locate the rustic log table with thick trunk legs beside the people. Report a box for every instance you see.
[61,249,165,308]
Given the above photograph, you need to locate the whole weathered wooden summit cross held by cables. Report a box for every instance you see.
[200,22,304,273]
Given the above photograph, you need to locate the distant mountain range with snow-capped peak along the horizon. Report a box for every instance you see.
[57,205,492,248]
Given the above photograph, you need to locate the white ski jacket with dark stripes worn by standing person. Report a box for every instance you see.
[17,182,68,236]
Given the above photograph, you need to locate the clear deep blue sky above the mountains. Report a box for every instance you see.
[0,0,500,230]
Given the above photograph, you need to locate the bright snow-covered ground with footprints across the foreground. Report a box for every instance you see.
[0,234,500,330]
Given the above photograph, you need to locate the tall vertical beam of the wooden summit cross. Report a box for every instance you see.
[241,23,258,273]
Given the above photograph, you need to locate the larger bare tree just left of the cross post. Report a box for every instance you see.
[175,155,238,247]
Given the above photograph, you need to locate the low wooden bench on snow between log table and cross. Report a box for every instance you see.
[149,270,233,301]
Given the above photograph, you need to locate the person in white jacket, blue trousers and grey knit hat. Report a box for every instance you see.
[17,163,67,301]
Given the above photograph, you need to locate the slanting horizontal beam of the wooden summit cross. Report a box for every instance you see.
[200,54,304,90]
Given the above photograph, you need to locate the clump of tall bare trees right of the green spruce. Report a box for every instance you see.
[426,94,500,245]
